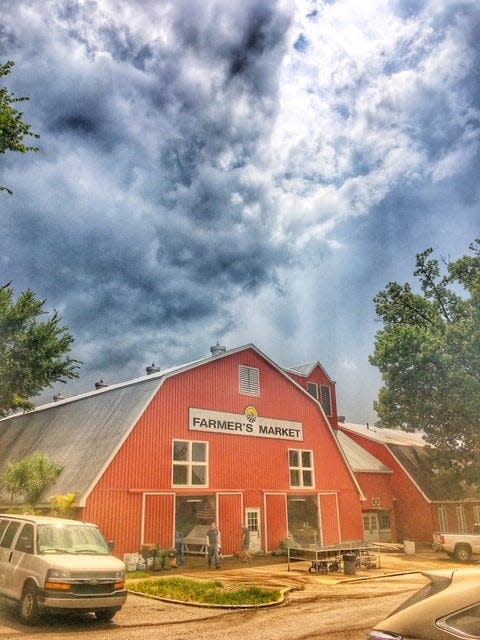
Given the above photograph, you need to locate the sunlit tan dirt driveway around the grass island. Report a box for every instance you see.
[0,548,465,640]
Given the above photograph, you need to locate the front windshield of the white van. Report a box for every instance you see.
[38,523,110,554]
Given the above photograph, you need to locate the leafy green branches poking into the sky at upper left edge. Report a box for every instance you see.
[0,60,40,195]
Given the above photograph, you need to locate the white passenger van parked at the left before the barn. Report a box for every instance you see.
[0,514,127,624]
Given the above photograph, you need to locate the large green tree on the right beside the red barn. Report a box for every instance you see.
[370,240,480,487]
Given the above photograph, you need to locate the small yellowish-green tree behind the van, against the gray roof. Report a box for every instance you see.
[0,453,63,509]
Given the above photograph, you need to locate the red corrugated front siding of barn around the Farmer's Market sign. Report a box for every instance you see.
[88,350,362,552]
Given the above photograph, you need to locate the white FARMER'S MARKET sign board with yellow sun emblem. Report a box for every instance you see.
[188,407,303,441]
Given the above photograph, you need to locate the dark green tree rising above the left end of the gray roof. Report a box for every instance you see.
[0,285,80,414]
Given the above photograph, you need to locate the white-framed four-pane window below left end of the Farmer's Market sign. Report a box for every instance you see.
[172,440,208,487]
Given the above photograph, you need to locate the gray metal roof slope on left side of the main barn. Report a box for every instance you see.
[0,375,163,504]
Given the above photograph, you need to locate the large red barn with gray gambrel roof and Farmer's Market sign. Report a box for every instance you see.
[0,345,363,555]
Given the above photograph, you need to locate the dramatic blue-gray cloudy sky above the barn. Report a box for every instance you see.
[0,0,480,422]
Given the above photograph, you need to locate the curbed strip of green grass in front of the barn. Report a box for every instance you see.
[129,577,281,606]
